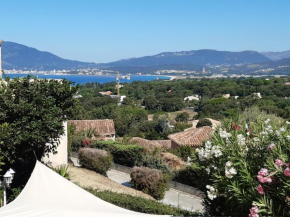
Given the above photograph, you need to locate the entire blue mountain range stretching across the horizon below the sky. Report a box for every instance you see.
[2,41,290,73]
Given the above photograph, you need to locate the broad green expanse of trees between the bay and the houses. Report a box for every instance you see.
[74,77,290,139]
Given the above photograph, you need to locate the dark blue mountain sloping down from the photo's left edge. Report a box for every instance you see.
[2,41,96,70]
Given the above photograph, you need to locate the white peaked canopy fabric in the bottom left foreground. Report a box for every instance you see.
[0,161,170,217]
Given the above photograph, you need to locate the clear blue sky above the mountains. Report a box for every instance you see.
[0,0,290,63]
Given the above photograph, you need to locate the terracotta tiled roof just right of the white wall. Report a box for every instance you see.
[68,119,115,136]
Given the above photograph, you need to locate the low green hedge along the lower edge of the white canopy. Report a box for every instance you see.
[86,189,199,216]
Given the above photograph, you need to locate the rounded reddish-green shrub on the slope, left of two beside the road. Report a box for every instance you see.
[79,148,113,175]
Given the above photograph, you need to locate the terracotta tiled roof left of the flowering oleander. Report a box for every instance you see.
[168,126,213,146]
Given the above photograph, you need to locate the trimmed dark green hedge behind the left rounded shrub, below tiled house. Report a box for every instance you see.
[91,141,144,167]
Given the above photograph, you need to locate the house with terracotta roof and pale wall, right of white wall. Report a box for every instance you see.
[68,119,116,141]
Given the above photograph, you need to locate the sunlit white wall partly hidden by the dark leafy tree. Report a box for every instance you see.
[42,122,68,167]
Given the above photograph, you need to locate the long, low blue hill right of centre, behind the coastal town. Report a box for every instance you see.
[99,50,271,67]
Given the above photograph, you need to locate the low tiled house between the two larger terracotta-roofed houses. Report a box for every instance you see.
[130,137,171,149]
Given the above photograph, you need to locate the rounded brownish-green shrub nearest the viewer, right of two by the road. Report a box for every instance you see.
[130,167,168,200]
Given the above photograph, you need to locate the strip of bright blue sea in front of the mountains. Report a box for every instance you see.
[6,74,170,84]
